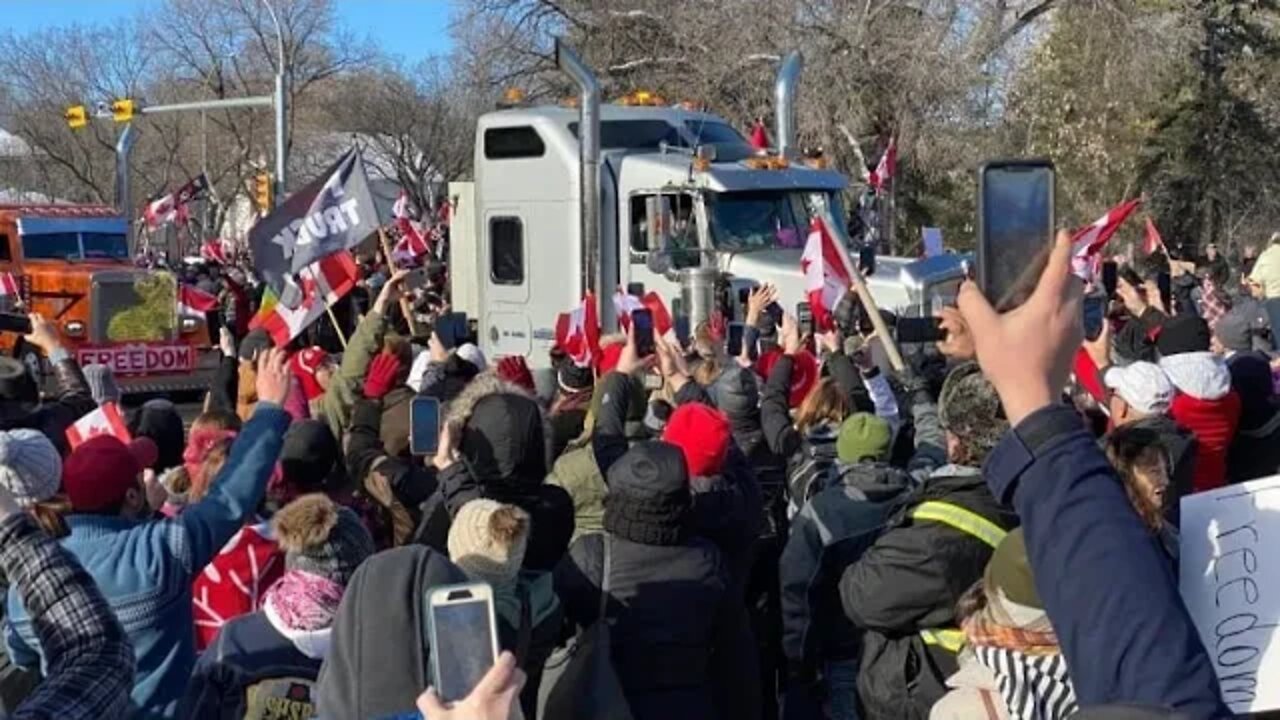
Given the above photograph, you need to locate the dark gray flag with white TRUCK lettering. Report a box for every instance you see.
[248,149,378,291]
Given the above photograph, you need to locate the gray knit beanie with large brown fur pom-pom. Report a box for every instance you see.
[271,493,375,585]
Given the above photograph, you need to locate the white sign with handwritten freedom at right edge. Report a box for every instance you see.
[1180,475,1280,714]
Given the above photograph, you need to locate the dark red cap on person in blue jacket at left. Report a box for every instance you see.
[63,436,160,512]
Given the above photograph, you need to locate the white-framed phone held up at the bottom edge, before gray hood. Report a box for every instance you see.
[426,583,498,702]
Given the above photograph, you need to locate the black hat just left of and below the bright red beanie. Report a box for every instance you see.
[604,442,692,546]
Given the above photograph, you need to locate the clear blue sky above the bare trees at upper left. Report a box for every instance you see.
[0,0,453,60]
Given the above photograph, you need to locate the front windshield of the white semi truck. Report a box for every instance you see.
[705,190,847,251]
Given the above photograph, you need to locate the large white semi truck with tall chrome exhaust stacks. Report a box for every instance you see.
[449,45,963,386]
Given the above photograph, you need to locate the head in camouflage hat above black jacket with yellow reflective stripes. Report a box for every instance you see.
[938,363,1009,466]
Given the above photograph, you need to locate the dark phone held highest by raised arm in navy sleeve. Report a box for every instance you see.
[978,161,1053,302]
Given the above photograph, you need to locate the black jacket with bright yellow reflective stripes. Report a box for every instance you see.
[840,465,1018,720]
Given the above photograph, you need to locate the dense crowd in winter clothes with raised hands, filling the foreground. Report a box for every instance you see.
[0,225,1280,720]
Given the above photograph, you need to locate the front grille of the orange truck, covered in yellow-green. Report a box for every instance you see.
[90,272,178,343]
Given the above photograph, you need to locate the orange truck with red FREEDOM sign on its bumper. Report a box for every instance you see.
[0,205,218,393]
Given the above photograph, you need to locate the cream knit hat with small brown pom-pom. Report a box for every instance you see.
[449,498,529,587]
